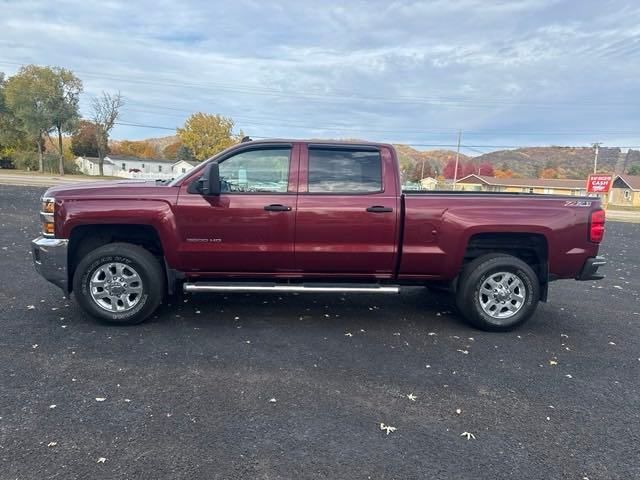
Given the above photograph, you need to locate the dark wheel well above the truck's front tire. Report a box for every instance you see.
[68,224,164,291]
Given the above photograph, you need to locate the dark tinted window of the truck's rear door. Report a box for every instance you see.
[309,147,382,193]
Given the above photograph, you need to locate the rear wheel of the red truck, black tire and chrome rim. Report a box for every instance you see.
[456,253,540,332]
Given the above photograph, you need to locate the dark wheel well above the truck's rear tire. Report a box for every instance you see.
[462,232,549,301]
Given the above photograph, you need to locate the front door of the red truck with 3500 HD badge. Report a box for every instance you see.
[175,143,298,276]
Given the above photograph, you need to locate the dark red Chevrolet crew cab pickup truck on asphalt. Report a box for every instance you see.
[33,140,605,331]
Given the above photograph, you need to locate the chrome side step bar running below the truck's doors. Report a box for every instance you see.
[183,282,400,293]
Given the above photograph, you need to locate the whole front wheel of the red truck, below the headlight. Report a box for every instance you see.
[73,243,165,325]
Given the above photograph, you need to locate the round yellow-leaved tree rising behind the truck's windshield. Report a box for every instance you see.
[177,112,244,160]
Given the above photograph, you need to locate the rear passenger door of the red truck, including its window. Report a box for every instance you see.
[295,144,400,279]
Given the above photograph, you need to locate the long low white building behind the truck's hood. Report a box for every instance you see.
[75,155,197,180]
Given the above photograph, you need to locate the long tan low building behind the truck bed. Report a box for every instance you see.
[456,174,587,196]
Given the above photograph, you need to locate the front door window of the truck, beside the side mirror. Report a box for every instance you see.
[220,148,291,193]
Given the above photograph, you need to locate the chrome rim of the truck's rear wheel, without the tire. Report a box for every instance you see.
[478,272,527,320]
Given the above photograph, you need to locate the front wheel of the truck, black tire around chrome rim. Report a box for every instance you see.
[73,243,165,325]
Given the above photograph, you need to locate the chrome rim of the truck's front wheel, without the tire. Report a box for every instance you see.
[89,262,142,312]
